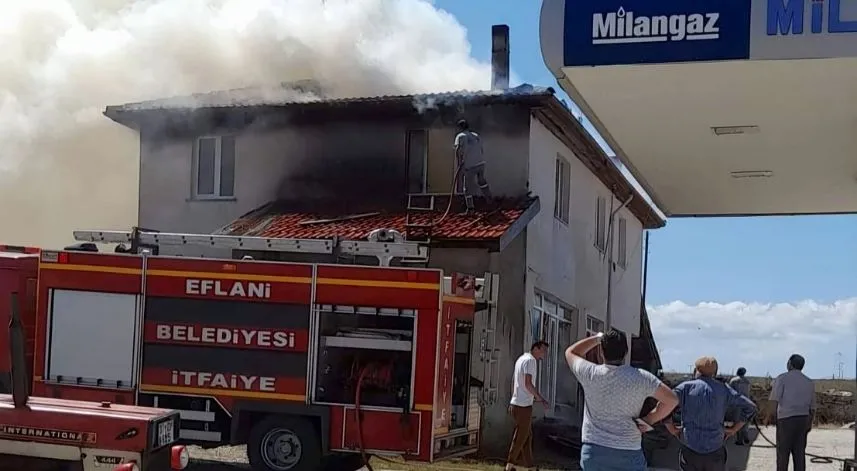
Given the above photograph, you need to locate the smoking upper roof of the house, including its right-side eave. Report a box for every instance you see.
[104,84,665,229]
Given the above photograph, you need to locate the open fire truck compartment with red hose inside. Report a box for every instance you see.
[314,305,416,409]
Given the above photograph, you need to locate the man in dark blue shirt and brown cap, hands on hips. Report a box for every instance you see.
[666,357,756,471]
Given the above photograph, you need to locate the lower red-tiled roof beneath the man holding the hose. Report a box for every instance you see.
[217,195,539,249]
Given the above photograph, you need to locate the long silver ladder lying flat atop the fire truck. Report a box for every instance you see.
[74,229,428,266]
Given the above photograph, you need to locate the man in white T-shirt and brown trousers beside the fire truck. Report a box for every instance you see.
[506,341,548,471]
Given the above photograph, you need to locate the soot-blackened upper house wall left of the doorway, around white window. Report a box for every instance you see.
[139,123,406,233]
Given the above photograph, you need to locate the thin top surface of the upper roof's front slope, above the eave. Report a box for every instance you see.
[106,84,554,113]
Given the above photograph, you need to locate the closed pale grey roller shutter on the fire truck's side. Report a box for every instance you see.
[47,289,139,389]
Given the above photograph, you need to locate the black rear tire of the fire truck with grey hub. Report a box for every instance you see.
[247,415,322,471]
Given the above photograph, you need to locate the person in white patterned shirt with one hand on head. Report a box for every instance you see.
[565,330,678,471]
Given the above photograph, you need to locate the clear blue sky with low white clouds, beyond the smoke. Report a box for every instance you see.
[434,0,857,377]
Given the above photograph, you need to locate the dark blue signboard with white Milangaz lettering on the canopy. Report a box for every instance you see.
[563,0,750,67]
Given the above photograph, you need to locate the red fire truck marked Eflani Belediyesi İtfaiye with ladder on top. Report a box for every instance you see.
[15,228,499,471]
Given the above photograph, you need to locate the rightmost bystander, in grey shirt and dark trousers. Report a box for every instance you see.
[770,355,816,471]
